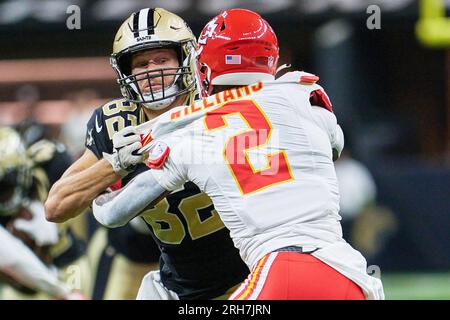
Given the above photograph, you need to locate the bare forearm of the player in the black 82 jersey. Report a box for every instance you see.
[45,149,121,222]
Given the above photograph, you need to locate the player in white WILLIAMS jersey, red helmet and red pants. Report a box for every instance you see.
[93,9,384,299]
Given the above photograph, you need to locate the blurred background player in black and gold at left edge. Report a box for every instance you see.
[0,127,91,300]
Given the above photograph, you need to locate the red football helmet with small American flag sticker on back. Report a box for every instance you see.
[198,9,279,94]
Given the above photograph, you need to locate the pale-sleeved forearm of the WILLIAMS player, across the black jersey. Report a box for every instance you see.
[92,171,170,228]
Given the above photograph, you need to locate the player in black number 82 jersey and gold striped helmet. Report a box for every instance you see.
[46,8,248,299]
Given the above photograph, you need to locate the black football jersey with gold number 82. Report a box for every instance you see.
[86,99,249,299]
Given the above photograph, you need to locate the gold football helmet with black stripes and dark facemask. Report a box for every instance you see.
[111,8,200,110]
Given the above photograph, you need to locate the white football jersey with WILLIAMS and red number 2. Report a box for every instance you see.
[151,72,343,267]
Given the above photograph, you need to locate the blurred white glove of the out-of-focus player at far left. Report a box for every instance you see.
[13,200,58,246]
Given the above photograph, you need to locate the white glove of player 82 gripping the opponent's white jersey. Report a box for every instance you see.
[103,126,143,176]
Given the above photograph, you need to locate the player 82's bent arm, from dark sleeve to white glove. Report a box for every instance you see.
[45,108,142,222]
